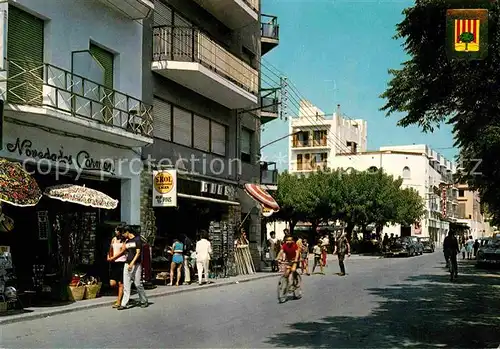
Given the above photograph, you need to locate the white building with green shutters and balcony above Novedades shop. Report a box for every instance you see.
[0,0,153,239]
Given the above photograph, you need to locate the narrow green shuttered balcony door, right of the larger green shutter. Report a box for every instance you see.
[90,43,114,126]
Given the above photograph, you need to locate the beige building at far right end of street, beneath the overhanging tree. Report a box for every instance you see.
[457,184,491,238]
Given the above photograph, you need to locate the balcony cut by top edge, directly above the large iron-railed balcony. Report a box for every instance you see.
[194,0,260,30]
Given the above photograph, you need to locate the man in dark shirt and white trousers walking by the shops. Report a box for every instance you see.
[111,226,148,310]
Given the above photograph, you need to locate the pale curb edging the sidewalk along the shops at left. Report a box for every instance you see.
[0,273,278,325]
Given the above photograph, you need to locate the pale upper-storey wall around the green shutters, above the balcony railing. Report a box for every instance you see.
[6,0,142,99]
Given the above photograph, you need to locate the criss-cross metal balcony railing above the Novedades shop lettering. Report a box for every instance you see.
[3,60,153,136]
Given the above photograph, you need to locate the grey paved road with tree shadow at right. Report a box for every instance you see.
[0,253,500,348]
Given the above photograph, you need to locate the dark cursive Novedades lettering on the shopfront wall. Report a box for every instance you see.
[6,138,115,173]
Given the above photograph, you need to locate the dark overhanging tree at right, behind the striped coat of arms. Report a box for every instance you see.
[382,0,500,217]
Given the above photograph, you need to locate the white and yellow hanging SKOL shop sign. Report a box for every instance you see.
[153,170,177,207]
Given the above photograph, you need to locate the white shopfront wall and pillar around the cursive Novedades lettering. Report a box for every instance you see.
[0,122,143,224]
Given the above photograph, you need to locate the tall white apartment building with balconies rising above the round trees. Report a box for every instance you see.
[288,100,367,173]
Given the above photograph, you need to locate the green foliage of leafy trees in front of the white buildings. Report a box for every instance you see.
[272,171,425,231]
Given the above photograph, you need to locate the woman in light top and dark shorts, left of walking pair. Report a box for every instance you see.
[108,226,127,308]
